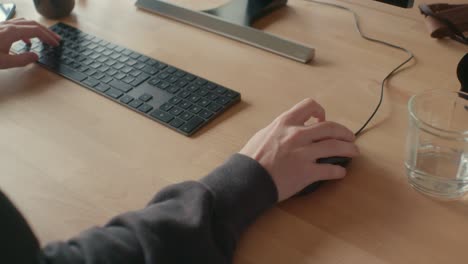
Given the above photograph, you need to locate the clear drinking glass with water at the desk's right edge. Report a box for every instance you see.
[405,90,468,200]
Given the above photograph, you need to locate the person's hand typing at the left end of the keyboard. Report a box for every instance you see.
[0,18,61,69]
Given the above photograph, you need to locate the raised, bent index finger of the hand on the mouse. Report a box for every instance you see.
[284,98,325,126]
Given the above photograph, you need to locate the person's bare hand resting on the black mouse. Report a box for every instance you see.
[240,99,359,201]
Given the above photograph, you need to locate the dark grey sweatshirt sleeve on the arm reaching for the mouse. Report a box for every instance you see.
[0,154,278,264]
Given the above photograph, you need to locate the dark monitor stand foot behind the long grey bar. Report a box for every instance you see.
[203,0,288,27]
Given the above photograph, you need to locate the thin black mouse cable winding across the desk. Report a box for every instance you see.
[304,0,414,136]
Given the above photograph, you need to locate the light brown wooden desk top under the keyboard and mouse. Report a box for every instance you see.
[0,0,468,264]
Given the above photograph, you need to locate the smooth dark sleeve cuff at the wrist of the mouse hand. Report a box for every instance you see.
[201,154,278,237]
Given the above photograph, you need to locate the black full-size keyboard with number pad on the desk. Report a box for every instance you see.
[12,23,240,136]
